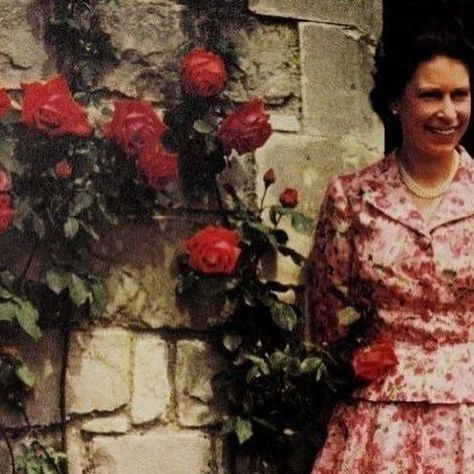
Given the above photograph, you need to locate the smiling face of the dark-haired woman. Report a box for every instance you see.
[395,56,471,158]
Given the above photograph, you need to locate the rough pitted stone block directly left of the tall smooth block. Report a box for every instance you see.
[228,18,301,116]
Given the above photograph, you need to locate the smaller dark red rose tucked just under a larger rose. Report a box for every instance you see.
[137,147,178,189]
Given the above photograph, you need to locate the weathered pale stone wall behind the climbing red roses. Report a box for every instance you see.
[0,0,383,474]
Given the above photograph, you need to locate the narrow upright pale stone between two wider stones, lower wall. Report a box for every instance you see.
[131,336,171,424]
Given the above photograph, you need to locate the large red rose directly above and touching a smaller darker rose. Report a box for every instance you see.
[104,100,166,155]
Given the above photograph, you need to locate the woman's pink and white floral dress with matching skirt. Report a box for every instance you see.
[312,149,474,474]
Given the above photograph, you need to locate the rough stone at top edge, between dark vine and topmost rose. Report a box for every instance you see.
[102,0,185,102]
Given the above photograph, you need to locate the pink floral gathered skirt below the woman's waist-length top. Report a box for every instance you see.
[312,400,474,474]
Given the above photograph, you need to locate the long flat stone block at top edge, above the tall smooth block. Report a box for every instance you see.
[249,0,382,37]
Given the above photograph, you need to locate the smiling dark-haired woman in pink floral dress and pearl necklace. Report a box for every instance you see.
[312,26,474,474]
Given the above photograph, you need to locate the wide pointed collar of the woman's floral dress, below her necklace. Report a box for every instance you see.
[362,147,474,236]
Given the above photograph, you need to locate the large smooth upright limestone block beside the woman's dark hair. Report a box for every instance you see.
[300,23,383,147]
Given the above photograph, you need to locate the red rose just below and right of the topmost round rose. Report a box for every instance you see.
[217,99,272,154]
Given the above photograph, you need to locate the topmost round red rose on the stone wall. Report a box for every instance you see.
[181,48,227,97]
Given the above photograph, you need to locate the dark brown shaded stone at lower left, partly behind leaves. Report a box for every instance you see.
[0,331,62,427]
